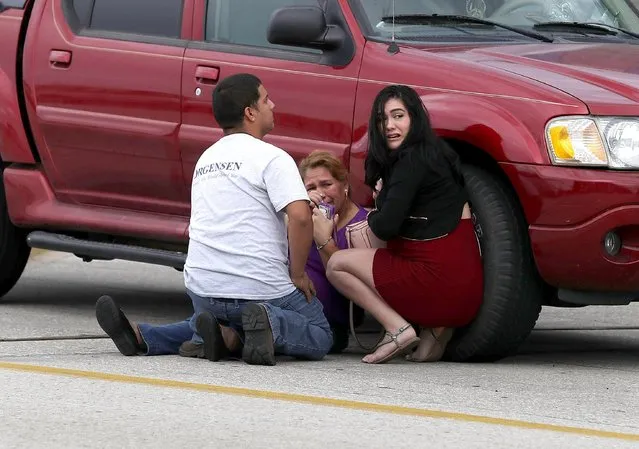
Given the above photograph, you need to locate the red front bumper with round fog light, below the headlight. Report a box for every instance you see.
[502,164,639,296]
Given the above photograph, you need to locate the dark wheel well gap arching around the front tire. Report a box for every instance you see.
[446,139,560,305]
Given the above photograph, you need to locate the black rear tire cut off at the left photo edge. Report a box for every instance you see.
[0,172,31,299]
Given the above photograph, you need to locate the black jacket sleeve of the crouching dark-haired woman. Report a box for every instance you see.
[368,156,425,240]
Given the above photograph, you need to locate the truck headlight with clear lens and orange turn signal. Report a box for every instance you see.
[546,117,639,168]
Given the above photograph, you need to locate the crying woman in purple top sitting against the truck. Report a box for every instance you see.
[299,151,368,353]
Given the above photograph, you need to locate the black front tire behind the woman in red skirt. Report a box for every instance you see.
[445,165,543,362]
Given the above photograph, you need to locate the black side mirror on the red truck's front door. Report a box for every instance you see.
[266,6,345,50]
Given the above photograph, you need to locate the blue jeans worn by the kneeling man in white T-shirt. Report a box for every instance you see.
[187,289,333,360]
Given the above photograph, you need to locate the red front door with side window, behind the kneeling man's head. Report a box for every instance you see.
[180,0,361,192]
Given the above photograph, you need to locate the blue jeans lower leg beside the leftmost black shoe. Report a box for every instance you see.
[138,315,202,355]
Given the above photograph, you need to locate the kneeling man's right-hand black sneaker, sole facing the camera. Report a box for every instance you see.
[242,304,275,366]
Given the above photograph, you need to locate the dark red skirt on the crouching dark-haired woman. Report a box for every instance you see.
[373,219,484,327]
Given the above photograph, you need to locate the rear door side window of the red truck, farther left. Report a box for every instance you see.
[68,0,184,38]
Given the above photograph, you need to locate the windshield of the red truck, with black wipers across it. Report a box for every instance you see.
[351,0,639,43]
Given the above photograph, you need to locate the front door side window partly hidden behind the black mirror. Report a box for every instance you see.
[204,0,321,53]
